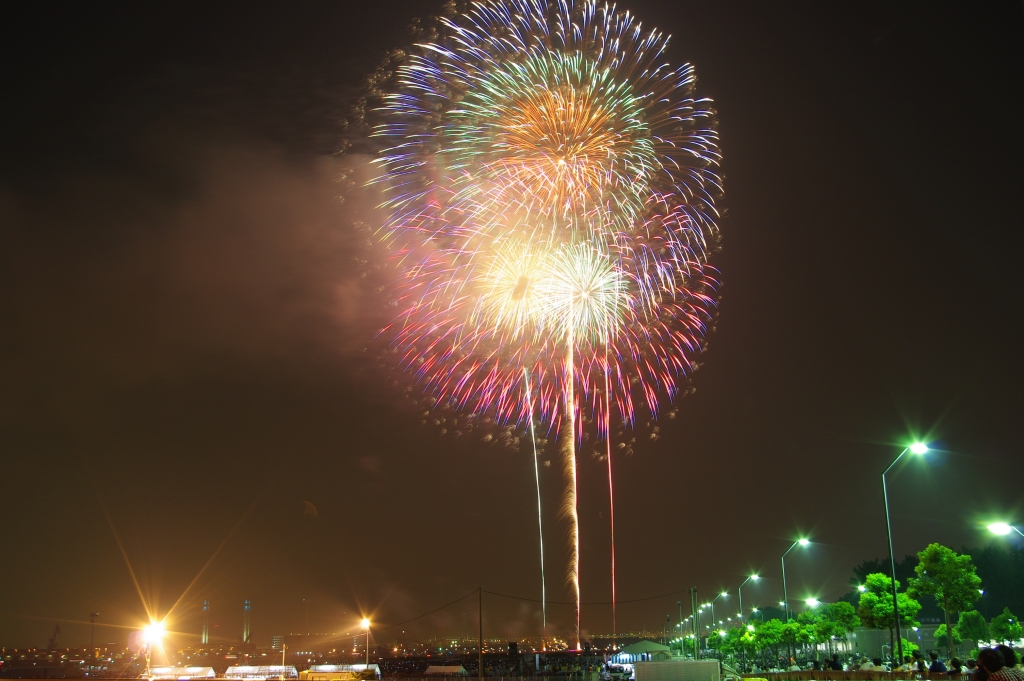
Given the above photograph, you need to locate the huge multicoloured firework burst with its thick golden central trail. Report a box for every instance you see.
[373,0,721,634]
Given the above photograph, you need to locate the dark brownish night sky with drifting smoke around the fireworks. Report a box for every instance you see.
[0,0,1024,646]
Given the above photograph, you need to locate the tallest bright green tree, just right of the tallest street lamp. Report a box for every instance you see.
[909,544,981,654]
